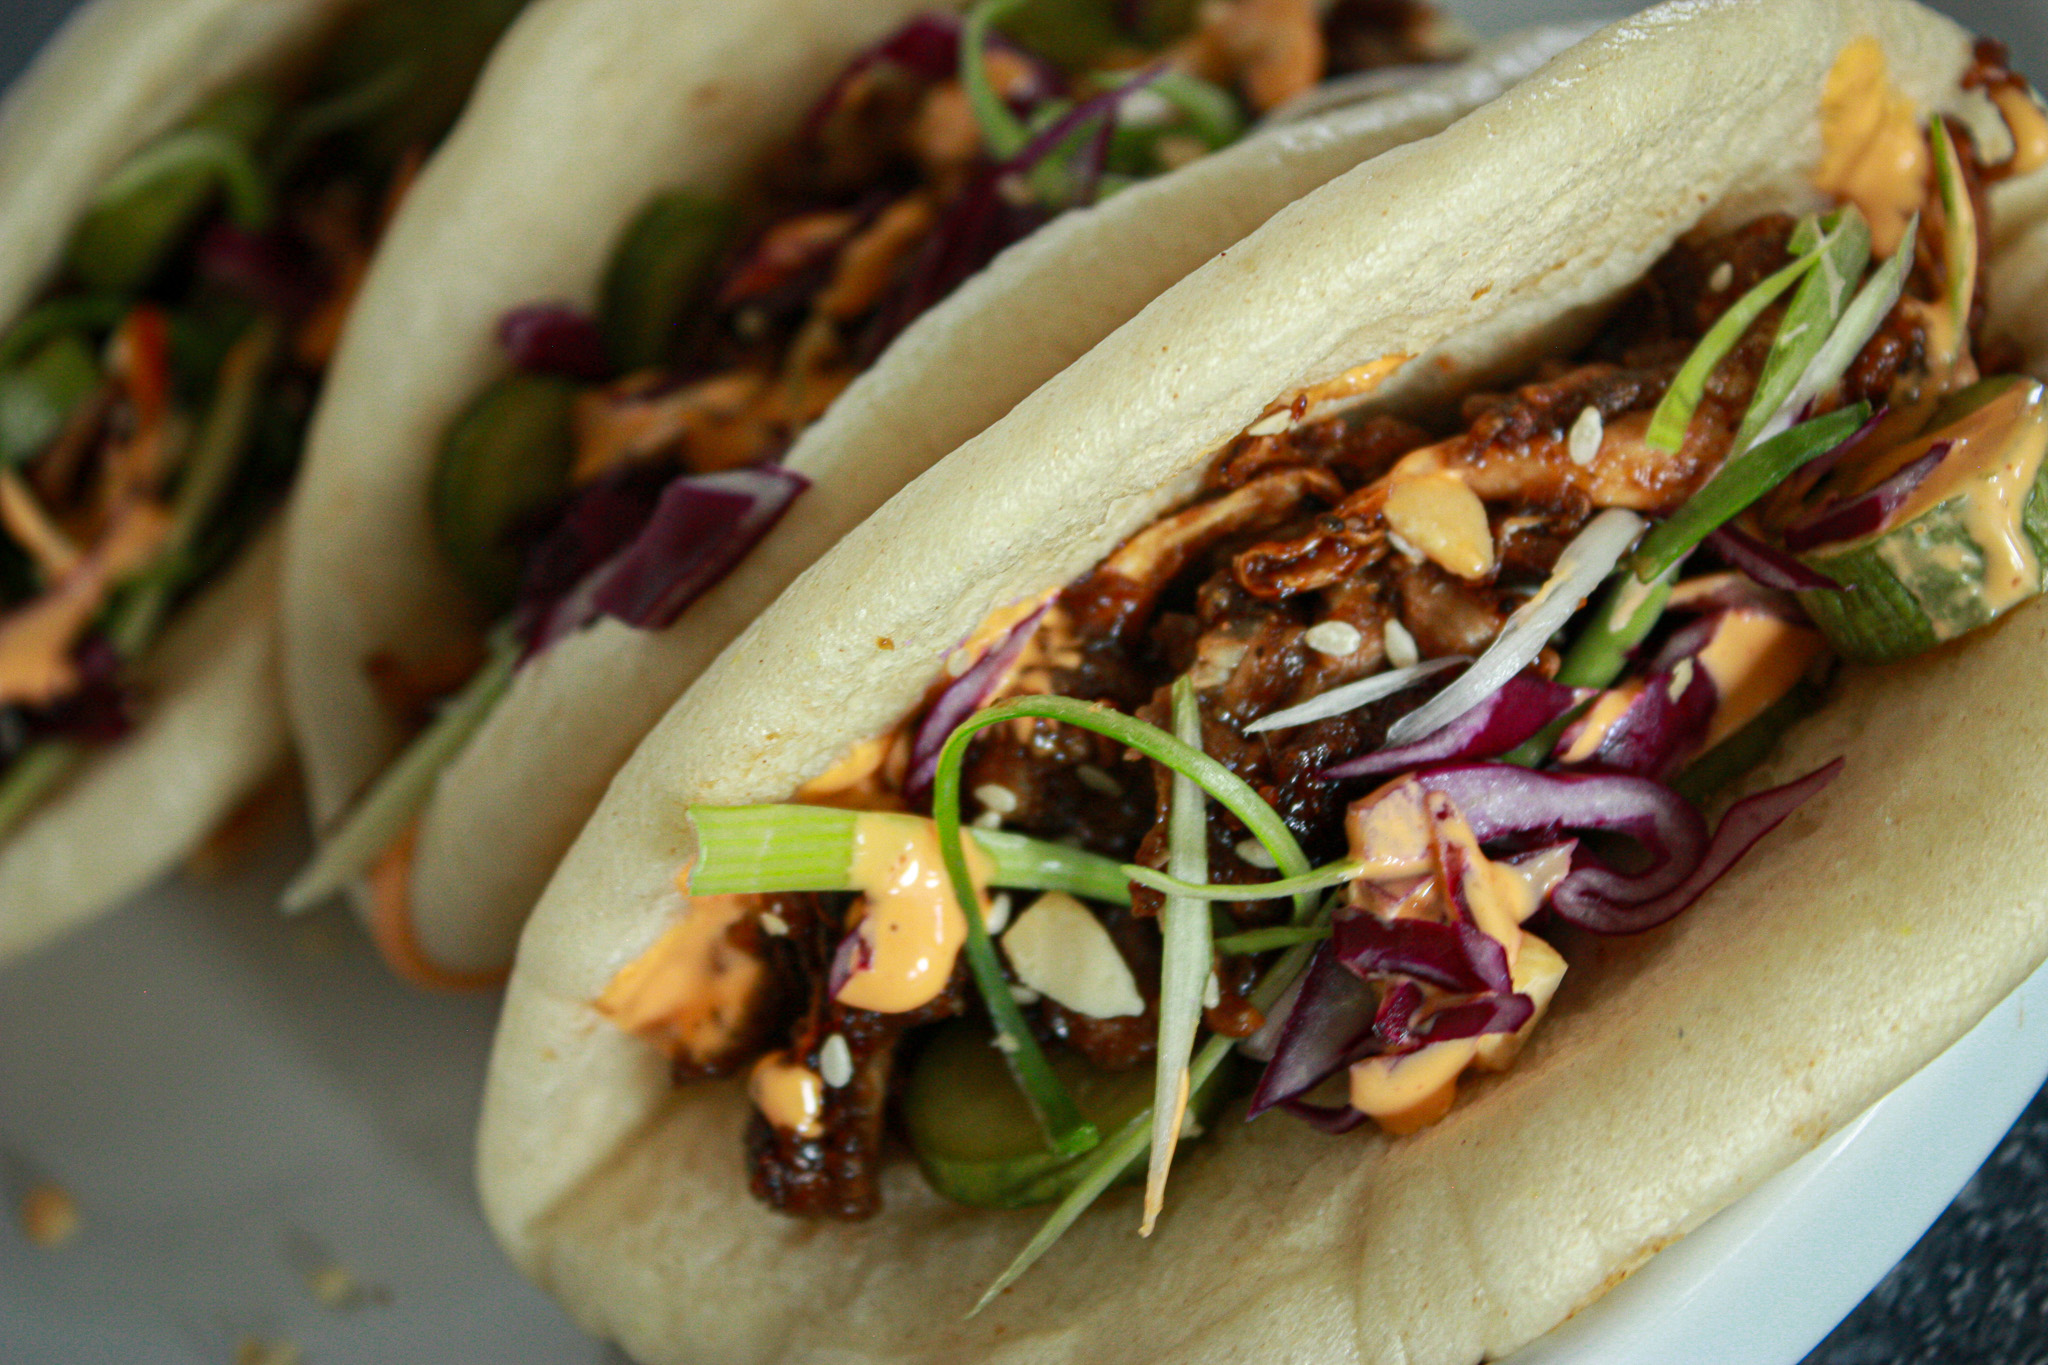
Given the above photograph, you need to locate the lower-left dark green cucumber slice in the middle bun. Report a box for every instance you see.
[434,375,578,610]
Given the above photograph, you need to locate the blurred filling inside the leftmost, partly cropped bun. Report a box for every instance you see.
[0,0,536,831]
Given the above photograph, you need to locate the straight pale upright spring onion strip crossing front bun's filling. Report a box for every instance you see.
[1139,675,1217,1236]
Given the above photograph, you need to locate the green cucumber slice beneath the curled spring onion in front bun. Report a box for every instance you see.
[903,1019,1229,1209]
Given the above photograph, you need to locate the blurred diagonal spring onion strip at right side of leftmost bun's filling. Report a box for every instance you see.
[106,319,279,659]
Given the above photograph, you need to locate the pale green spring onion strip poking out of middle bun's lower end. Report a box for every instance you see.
[281,632,520,915]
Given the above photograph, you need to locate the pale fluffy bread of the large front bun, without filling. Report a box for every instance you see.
[479,0,2048,1365]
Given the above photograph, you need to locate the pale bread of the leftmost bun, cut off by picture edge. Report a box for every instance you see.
[0,0,356,962]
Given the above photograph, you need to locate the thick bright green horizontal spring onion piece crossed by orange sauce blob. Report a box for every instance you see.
[684,804,1130,905]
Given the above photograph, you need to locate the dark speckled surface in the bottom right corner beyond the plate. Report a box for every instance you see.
[1806,1091,2048,1365]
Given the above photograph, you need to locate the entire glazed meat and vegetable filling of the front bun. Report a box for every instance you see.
[598,31,2048,1254]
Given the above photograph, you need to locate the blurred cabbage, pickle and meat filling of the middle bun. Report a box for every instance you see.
[287,0,1460,965]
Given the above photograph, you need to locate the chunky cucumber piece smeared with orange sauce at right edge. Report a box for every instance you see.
[1800,383,2048,663]
